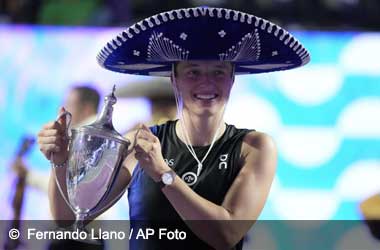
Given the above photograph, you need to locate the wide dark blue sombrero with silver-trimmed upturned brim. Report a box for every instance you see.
[97,7,310,76]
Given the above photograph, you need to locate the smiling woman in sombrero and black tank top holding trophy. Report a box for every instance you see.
[39,7,309,249]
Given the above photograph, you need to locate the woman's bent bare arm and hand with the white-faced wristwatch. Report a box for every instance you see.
[136,129,277,249]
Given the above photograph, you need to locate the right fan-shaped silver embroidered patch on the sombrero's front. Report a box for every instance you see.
[219,30,261,62]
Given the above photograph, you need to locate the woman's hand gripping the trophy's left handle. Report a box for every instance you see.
[38,107,69,165]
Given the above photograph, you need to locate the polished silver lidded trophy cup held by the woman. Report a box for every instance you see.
[53,86,130,234]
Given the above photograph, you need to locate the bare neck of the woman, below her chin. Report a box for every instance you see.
[176,110,226,146]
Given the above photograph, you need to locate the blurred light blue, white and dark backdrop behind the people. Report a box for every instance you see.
[0,0,380,249]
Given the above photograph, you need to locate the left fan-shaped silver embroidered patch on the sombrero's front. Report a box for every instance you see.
[147,32,189,61]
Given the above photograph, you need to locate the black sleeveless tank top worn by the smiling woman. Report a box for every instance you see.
[128,121,250,250]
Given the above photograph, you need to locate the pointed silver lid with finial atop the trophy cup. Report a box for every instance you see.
[74,85,130,146]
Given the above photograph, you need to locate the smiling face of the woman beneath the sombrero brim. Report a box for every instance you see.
[176,61,234,116]
